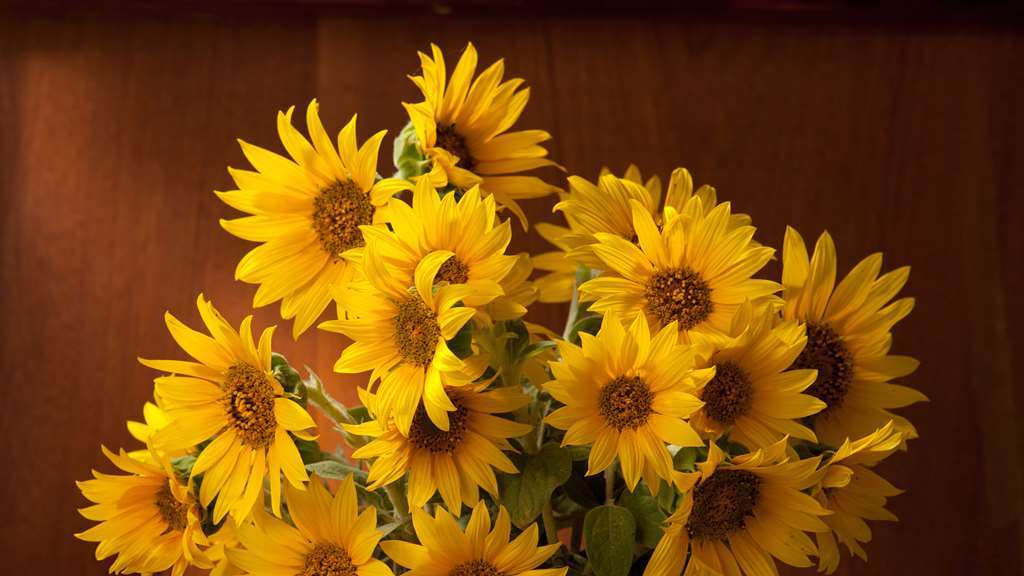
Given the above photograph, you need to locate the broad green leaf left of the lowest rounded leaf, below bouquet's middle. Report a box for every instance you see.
[498,444,572,529]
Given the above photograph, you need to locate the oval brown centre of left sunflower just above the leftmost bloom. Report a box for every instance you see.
[223,362,278,448]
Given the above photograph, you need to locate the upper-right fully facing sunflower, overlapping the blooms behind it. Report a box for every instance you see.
[580,196,779,337]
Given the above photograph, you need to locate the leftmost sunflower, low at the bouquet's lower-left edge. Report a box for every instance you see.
[75,447,212,576]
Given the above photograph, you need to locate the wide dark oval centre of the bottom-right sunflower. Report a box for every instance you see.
[686,469,761,540]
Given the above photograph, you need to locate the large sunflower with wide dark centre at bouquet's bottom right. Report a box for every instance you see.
[644,439,829,576]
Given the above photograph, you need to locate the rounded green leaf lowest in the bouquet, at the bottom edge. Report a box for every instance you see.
[583,504,637,576]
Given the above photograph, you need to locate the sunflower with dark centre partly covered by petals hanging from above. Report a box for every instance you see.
[345,383,532,513]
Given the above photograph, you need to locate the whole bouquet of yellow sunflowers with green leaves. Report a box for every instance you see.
[77,45,926,576]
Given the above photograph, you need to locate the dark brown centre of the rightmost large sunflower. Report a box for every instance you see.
[793,323,853,413]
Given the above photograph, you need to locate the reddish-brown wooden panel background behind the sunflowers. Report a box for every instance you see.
[0,3,1024,574]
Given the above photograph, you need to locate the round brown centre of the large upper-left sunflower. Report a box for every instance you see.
[313,179,374,258]
